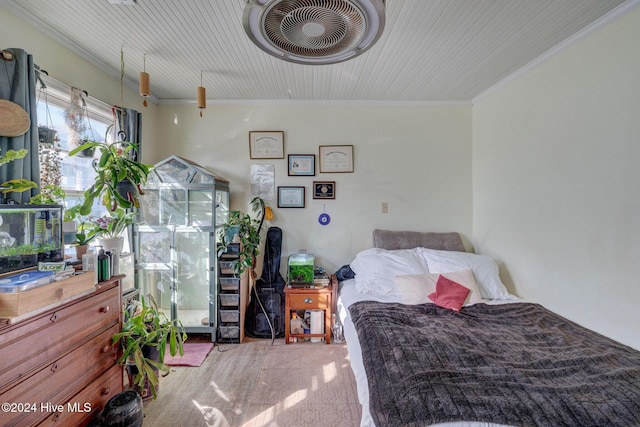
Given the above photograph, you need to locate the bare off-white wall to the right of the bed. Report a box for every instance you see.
[473,8,640,349]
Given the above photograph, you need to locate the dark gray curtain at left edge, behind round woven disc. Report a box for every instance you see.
[0,48,40,203]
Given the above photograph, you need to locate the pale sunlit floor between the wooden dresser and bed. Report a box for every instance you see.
[144,338,360,427]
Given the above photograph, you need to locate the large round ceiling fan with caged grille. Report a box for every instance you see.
[243,0,385,65]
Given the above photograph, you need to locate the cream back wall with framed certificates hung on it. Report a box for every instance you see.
[153,104,471,273]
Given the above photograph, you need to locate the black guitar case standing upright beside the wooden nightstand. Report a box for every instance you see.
[244,227,285,339]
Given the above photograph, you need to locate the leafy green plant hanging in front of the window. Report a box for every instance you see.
[69,141,153,215]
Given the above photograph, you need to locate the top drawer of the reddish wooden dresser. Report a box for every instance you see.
[0,286,121,393]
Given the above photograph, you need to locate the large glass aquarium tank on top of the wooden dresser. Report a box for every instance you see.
[0,205,64,274]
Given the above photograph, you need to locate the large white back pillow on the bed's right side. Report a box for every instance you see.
[419,248,513,300]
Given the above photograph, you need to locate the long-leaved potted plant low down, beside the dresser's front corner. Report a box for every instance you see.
[113,295,187,399]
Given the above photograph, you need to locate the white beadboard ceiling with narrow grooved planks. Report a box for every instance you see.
[0,0,640,103]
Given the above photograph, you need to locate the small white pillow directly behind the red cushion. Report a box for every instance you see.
[395,270,482,306]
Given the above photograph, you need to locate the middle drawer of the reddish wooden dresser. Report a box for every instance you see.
[0,324,122,426]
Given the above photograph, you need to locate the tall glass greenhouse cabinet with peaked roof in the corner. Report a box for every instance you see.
[134,156,229,340]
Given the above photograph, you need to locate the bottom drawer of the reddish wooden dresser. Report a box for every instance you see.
[40,365,124,427]
